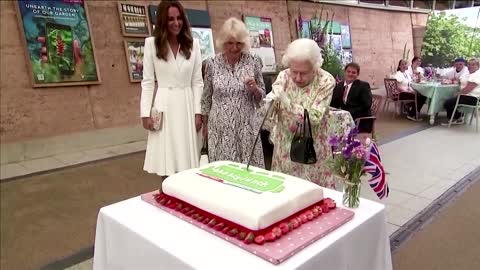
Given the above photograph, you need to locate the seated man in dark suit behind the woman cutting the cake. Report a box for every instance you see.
[330,63,373,133]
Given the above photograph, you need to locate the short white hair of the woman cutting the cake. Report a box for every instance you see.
[282,38,323,68]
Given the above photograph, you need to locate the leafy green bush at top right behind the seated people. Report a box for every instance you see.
[422,12,480,67]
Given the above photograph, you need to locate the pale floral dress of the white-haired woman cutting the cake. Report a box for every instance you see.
[272,69,335,187]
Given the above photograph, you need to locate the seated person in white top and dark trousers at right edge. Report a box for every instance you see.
[443,58,480,125]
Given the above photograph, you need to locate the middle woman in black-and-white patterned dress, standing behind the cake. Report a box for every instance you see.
[202,18,265,168]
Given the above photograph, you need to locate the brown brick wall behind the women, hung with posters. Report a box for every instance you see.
[0,0,426,143]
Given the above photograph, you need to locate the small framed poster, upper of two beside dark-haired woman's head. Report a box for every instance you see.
[118,2,150,37]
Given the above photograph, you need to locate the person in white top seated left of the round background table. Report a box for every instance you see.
[395,59,427,121]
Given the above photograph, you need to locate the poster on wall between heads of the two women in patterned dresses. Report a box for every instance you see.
[243,16,277,72]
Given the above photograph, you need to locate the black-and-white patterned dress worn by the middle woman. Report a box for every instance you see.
[202,53,265,168]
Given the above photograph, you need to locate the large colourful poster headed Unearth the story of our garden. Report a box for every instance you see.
[16,0,101,87]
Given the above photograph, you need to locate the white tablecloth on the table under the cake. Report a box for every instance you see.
[93,189,392,270]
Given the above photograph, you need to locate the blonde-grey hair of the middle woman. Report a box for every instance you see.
[215,17,250,52]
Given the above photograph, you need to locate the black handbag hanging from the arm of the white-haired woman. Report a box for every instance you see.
[290,109,317,164]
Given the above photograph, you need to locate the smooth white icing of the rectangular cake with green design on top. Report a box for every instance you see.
[162,161,323,231]
